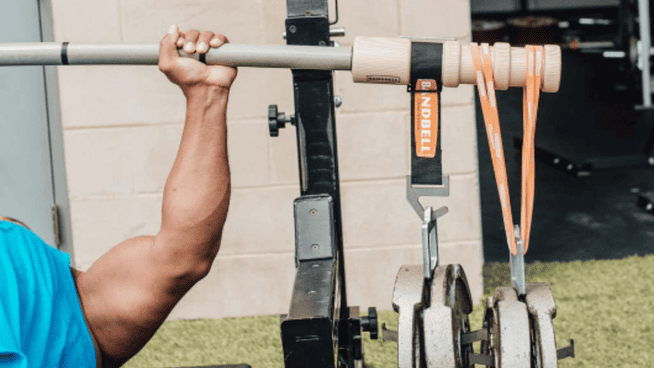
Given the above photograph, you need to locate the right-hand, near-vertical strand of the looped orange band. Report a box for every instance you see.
[520,45,544,254]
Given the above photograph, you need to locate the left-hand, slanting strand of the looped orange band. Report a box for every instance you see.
[470,43,518,255]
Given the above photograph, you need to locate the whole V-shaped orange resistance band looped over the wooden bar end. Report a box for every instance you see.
[470,43,543,255]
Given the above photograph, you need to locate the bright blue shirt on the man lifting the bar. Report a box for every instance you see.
[0,221,96,368]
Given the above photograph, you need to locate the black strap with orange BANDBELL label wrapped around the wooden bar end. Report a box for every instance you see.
[408,42,443,185]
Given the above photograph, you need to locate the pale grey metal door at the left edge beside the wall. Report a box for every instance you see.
[0,0,55,245]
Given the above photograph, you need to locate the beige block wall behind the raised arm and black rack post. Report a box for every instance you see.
[53,0,483,319]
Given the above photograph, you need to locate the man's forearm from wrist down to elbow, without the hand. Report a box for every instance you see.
[157,87,230,265]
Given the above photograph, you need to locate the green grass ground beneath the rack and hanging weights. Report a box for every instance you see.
[125,255,654,368]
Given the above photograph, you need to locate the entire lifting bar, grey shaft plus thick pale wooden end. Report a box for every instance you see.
[0,37,561,93]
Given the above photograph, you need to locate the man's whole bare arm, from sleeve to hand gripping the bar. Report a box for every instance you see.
[76,27,236,367]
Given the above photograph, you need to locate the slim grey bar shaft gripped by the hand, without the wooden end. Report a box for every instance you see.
[0,42,352,70]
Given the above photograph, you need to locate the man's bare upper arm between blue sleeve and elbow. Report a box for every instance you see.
[77,236,202,361]
